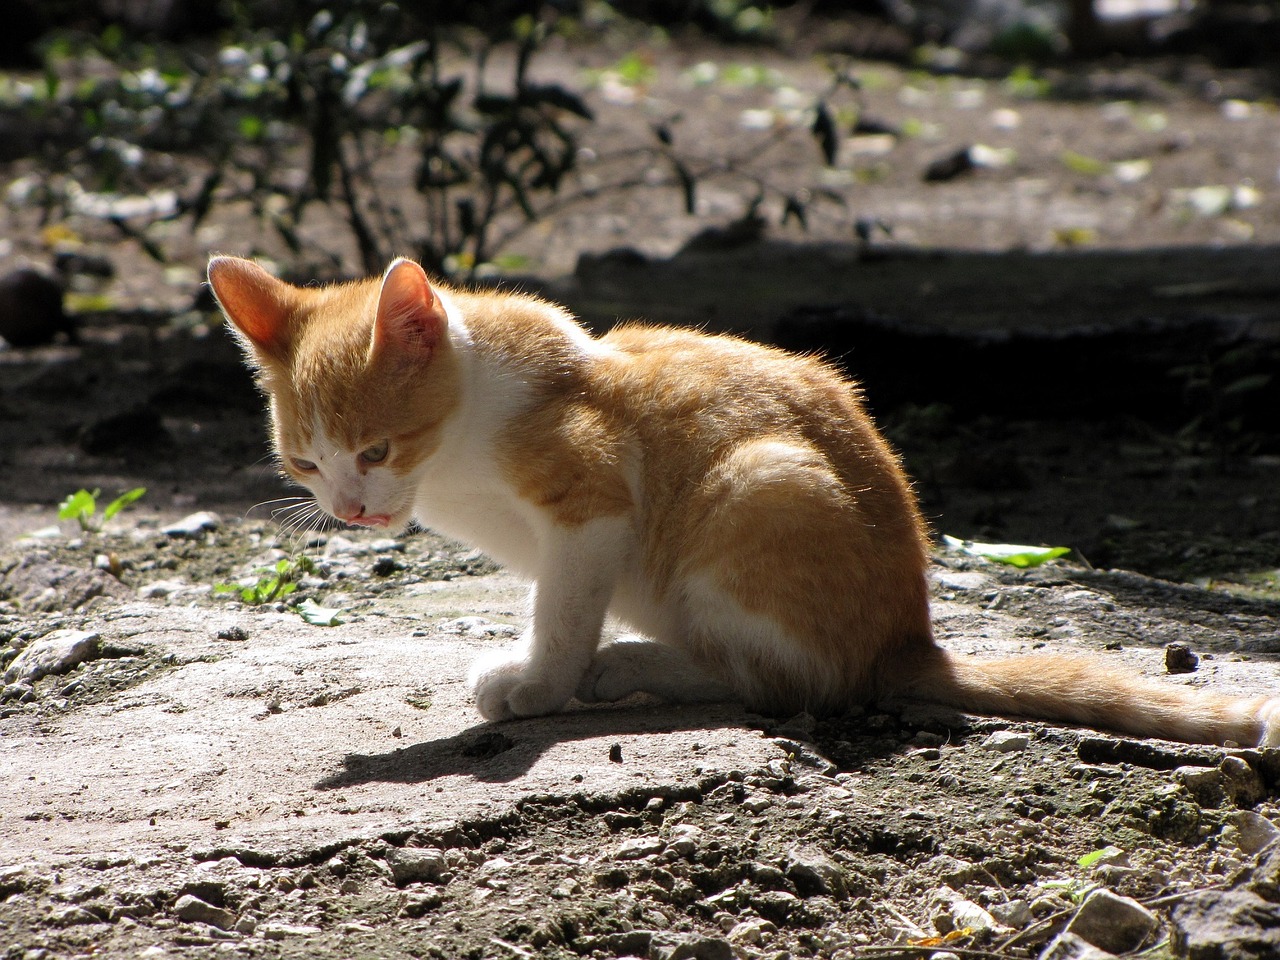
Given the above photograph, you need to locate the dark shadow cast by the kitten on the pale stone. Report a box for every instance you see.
[316,703,760,790]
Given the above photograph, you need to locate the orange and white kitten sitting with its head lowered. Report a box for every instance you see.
[209,256,1280,746]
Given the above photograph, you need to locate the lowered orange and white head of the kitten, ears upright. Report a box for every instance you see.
[209,256,460,530]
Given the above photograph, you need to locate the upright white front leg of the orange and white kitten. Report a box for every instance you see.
[471,517,632,721]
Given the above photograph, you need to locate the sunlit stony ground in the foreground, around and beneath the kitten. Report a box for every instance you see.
[0,513,1280,960]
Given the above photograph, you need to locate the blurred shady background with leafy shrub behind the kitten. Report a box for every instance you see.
[0,0,1280,596]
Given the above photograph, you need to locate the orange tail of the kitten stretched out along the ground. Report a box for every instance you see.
[895,648,1280,746]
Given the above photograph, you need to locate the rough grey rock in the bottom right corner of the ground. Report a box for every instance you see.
[1170,890,1280,960]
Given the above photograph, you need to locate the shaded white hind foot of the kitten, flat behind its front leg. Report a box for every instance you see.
[576,636,735,703]
